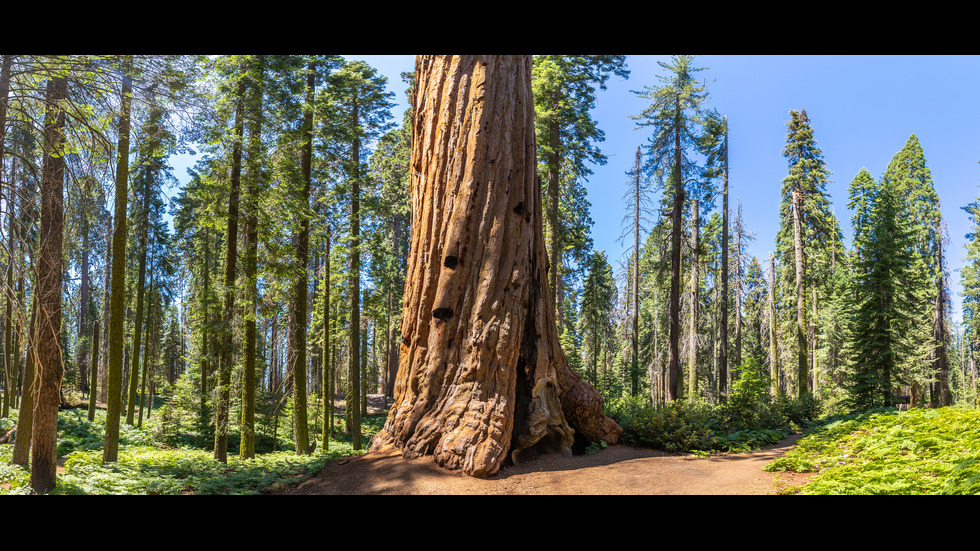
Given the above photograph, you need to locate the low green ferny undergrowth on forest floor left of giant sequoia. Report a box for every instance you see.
[0,410,384,495]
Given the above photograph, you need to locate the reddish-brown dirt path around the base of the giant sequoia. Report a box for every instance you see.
[283,434,799,495]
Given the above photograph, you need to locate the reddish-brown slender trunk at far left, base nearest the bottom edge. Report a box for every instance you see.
[31,76,68,494]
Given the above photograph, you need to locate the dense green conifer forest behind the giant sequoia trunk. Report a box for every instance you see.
[0,55,980,494]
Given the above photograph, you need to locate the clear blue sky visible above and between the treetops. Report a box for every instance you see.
[177,55,980,326]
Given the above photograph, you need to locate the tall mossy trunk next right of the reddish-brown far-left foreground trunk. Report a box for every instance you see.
[102,56,133,463]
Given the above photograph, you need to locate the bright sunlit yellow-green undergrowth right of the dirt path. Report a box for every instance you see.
[766,406,980,495]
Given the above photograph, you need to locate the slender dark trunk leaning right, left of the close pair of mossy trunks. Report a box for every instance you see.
[214,70,245,463]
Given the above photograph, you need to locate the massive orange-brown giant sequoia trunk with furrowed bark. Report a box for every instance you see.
[372,56,622,476]
